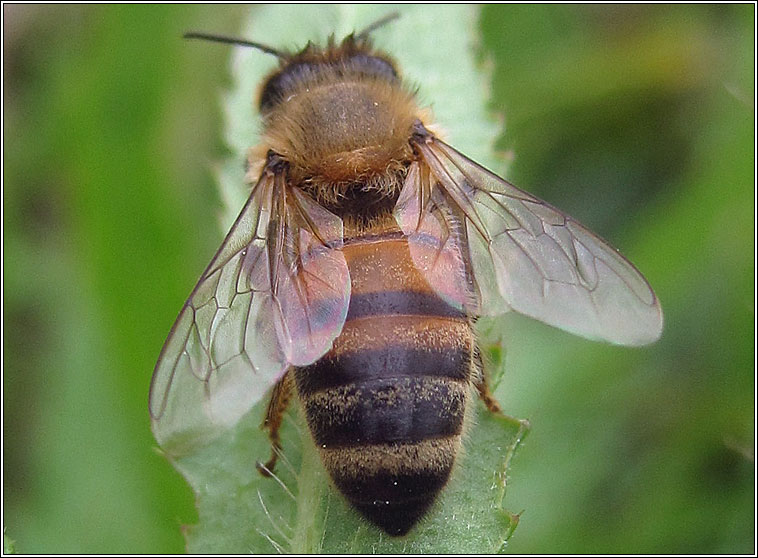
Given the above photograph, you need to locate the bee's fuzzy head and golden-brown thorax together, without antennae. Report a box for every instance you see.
[261,40,419,205]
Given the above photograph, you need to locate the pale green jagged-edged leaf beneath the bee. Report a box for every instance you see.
[158,5,527,553]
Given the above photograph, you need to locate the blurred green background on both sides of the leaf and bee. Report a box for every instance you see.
[3,4,755,553]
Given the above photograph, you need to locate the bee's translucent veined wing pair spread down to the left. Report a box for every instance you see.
[150,171,350,452]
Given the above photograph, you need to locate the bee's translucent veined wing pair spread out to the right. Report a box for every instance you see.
[395,138,663,345]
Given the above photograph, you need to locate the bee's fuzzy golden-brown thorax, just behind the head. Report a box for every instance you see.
[265,78,417,200]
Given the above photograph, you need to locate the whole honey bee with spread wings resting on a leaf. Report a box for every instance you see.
[150,13,662,536]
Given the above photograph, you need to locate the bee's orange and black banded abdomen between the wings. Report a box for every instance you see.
[294,228,474,535]
